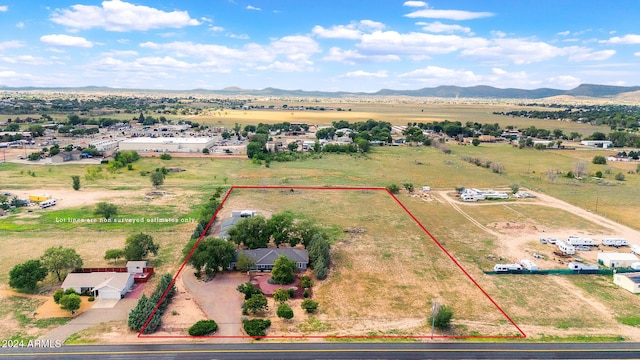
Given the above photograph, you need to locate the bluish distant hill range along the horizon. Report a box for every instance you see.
[0,84,640,99]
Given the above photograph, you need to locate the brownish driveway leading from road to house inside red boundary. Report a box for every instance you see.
[180,268,248,336]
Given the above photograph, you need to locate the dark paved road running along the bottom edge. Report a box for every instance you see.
[0,343,640,360]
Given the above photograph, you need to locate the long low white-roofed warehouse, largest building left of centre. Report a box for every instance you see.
[119,137,214,153]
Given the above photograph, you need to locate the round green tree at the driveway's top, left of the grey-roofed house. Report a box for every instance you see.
[189,237,235,275]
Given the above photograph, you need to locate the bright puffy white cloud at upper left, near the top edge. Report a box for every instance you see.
[51,0,201,32]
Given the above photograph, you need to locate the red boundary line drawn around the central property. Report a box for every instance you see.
[138,185,527,339]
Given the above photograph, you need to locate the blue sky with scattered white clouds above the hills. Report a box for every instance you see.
[0,0,640,91]
